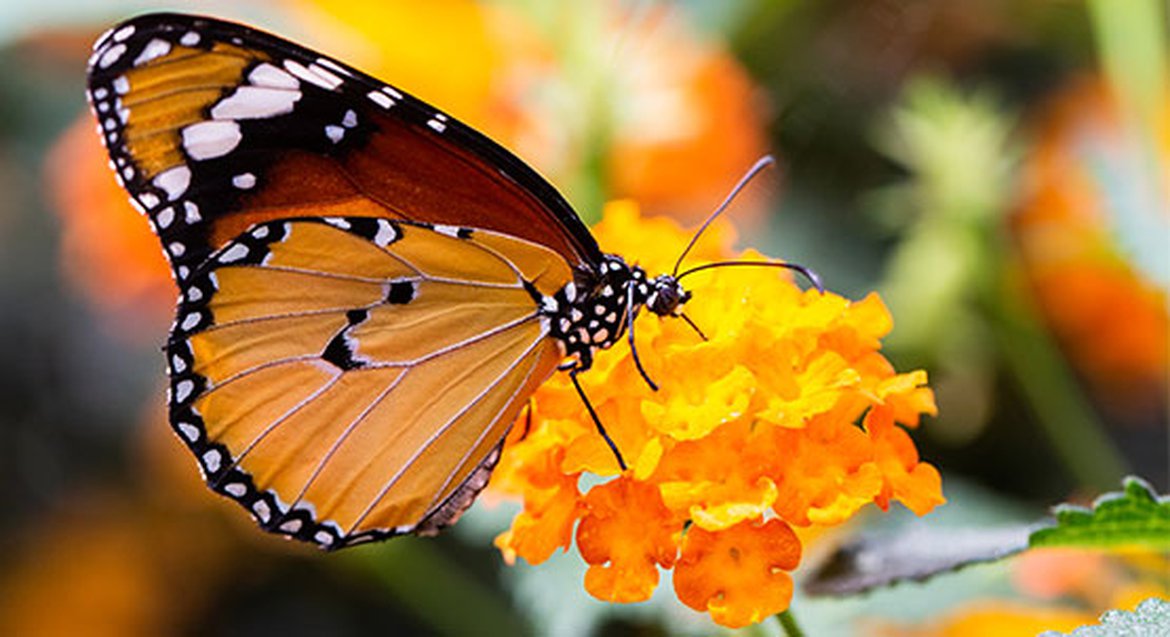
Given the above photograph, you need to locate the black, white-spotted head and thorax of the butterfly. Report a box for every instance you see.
[541,254,690,370]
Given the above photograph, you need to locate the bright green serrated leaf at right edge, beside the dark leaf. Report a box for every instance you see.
[1028,475,1170,550]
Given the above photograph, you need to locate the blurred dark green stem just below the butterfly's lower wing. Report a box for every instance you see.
[340,537,531,637]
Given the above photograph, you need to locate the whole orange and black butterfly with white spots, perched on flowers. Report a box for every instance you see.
[88,14,814,549]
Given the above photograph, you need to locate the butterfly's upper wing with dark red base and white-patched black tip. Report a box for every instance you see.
[88,9,600,282]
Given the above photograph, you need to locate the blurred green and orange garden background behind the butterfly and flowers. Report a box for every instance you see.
[0,0,1170,636]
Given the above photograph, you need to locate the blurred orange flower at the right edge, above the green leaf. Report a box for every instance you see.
[1014,81,1170,410]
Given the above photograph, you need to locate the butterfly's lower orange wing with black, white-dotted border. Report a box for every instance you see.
[167,217,572,548]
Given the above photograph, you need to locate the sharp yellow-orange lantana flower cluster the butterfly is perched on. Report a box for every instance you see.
[491,203,943,628]
